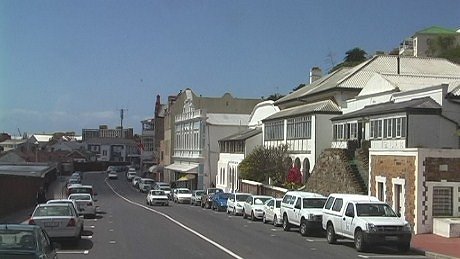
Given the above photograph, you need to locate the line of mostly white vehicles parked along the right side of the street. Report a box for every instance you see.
[158,188,412,254]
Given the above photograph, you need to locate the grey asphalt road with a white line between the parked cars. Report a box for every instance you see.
[55,173,426,259]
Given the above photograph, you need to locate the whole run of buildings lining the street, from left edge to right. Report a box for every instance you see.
[0,25,460,243]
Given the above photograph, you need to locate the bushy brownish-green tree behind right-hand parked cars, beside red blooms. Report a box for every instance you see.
[239,145,291,186]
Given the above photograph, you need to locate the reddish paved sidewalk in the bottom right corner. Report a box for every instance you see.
[411,234,460,259]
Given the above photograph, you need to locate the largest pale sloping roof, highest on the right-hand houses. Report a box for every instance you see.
[275,55,460,104]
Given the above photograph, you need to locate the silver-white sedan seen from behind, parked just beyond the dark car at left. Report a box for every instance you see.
[29,204,83,241]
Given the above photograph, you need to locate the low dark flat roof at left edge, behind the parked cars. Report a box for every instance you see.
[0,163,55,178]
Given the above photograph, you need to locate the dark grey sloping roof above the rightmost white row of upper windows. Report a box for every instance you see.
[331,97,441,121]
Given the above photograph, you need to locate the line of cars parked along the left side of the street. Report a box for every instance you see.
[0,172,96,258]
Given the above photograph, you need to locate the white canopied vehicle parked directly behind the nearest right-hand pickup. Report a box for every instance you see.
[280,191,327,236]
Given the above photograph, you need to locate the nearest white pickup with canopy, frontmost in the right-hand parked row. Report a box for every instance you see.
[322,193,412,251]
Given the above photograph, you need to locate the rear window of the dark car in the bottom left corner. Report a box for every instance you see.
[0,229,37,250]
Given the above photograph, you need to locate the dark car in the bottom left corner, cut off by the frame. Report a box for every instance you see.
[0,224,57,259]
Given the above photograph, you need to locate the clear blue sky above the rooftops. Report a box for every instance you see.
[0,0,460,135]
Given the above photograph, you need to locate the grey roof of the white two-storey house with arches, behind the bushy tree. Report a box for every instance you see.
[263,100,342,121]
